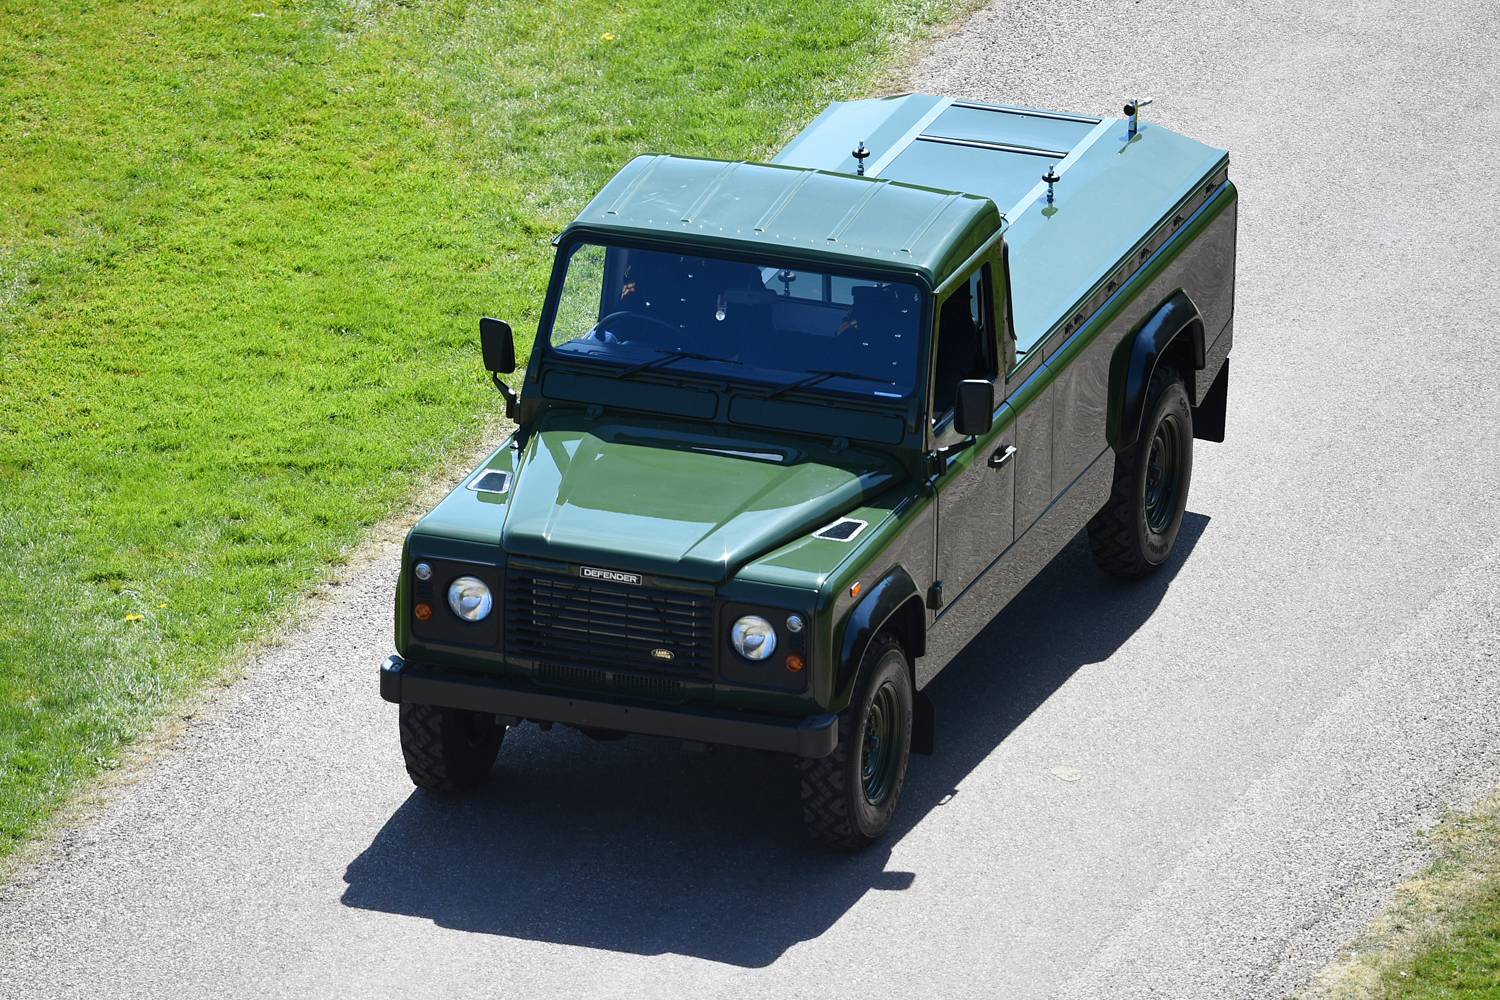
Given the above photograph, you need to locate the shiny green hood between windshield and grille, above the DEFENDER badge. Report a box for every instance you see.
[501,421,899,582]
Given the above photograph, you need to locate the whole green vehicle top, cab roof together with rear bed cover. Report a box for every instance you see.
[570,94,1229,344]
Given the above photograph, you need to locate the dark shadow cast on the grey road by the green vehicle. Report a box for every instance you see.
[344,513,1209,967]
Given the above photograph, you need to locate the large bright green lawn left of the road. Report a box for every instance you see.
[0,0,962,858]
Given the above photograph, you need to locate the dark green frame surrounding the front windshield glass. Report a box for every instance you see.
[533,226,933,411]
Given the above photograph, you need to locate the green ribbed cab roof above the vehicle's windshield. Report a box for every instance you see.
[566,156,1002,286]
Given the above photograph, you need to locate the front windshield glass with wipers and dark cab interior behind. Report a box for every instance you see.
[549,243,921,399]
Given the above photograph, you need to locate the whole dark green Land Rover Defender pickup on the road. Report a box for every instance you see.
[381,94,1236,849]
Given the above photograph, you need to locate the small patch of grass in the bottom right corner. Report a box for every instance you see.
[1302,793,1500,1000]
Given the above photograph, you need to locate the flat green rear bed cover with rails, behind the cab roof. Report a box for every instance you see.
[776,94,1229,351]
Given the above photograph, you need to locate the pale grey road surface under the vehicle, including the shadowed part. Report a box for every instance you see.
[0,0,1500,999]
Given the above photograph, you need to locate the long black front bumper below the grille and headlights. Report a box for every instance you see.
[380,657,839,757]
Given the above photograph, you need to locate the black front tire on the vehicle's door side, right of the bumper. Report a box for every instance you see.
[803,634,914,852]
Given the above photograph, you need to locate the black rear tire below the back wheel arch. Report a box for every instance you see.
[1089,364,1193,580]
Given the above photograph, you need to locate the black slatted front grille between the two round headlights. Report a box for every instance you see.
[506,567,714,681]
